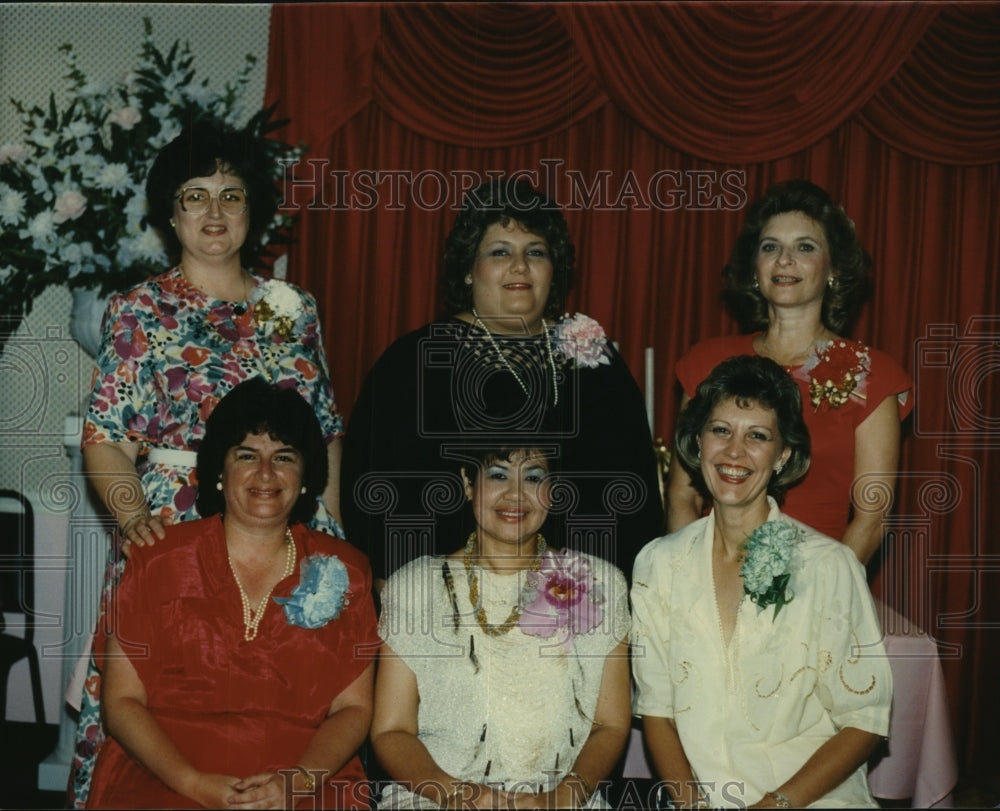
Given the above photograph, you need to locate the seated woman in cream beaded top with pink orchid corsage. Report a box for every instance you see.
[371,449,629,808]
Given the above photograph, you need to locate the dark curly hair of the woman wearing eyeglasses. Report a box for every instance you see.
[146,120,278,267]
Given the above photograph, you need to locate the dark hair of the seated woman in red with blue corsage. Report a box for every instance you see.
[197,377,329,523]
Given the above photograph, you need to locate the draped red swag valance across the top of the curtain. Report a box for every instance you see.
[268,3,1000,165]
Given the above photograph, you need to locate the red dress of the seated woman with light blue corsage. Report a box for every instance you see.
[87,516,379,809]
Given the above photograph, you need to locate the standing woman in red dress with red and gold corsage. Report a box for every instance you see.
[668,180,913,564]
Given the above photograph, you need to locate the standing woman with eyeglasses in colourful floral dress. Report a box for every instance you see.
[67,117,343,805]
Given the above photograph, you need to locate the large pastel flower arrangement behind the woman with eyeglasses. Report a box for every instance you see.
[0,18,304,338]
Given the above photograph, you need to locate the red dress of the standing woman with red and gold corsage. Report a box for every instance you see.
[676,333,913,540]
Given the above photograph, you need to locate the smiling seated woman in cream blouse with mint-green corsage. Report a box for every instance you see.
[632,356,892,808]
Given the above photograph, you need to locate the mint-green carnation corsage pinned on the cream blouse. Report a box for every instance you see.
[740,521,799,622]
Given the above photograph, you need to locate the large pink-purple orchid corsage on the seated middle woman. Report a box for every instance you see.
[518,549,604,650]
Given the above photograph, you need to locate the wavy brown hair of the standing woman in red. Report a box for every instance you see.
[722,180,872,335]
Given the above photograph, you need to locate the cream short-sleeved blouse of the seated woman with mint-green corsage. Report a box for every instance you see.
[632,501,892,808]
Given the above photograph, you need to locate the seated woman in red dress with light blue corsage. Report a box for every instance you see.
[88,378,378,808]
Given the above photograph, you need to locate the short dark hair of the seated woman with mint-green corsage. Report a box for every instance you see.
[674,355,810,501]
